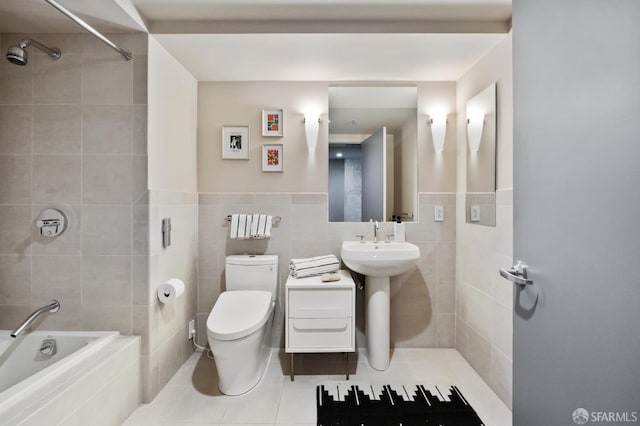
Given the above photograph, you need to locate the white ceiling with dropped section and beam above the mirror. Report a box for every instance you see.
[0,0,511,82]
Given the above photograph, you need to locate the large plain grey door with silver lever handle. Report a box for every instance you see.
[513,0,640,426]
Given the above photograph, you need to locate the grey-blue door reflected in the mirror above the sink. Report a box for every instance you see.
[362,127,387,222]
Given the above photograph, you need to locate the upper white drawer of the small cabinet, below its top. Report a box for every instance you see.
[287,288,353,318]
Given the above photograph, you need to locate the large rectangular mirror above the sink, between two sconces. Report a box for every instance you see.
[328,86,418,222]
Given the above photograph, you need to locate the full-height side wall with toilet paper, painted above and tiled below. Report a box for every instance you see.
[142,36,198,402]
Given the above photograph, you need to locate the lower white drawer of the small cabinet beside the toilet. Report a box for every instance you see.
[287,318,353,352]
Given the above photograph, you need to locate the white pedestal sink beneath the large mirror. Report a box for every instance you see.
[340,241,420,370]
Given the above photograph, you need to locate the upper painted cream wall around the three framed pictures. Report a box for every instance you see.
[198,82,328,192]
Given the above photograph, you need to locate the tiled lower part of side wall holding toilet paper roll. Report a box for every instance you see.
[138,190,198,402]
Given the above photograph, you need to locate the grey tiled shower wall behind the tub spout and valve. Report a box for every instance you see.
[0,33,147,346]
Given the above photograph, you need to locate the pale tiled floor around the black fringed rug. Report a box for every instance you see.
[124,349,512,426]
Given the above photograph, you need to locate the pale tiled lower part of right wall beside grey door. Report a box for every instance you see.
[456,189,513,407]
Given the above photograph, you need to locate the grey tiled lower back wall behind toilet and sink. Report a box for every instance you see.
[198,193,456,347]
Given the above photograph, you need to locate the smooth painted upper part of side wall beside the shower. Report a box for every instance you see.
[148,36,198,192]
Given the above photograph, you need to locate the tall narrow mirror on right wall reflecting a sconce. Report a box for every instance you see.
[465,83,497,226]
